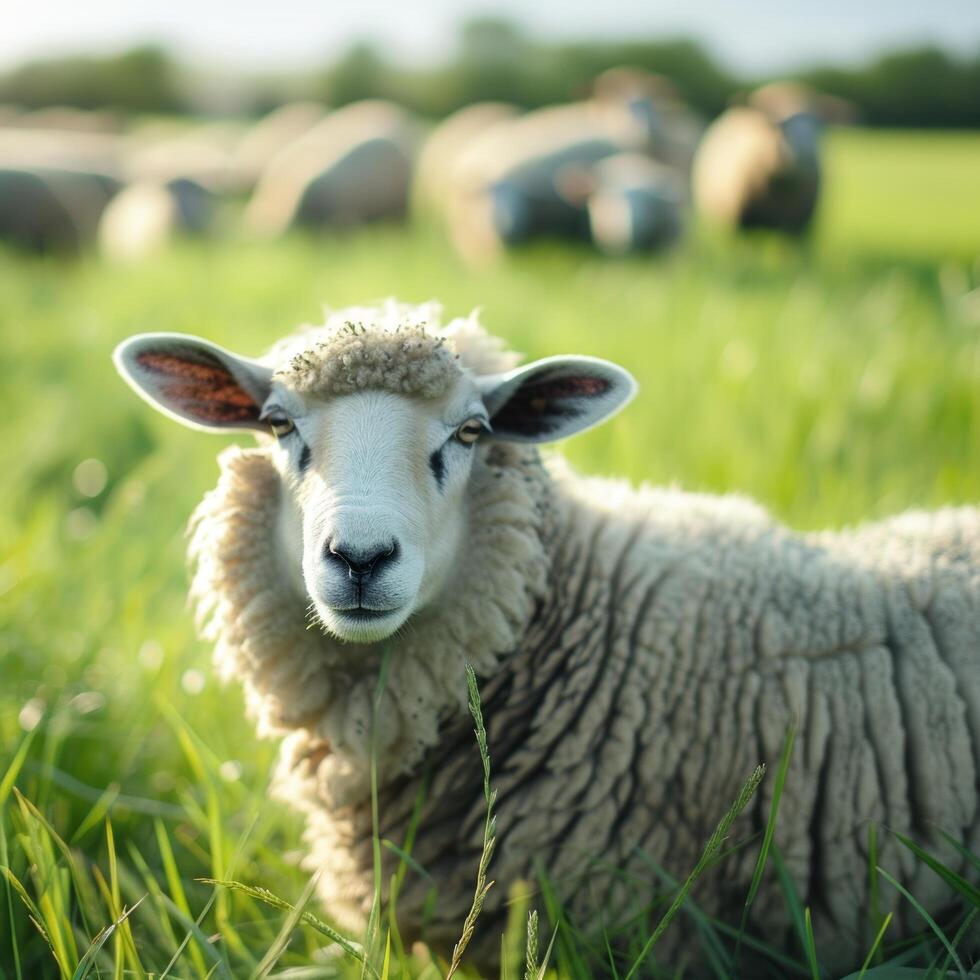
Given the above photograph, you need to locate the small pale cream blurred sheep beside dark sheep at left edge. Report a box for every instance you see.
[98,177,214,261]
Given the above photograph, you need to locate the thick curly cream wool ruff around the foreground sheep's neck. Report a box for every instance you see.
[184,444,550,805]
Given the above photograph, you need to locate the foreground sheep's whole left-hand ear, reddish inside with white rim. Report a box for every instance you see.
[112,333,272,432]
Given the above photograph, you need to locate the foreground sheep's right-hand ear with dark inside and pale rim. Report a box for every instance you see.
[480,357,637,442]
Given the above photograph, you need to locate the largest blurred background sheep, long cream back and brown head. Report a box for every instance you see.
[448,69,699,259]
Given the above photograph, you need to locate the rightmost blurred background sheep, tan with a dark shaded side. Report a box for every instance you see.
[692,83,846,234]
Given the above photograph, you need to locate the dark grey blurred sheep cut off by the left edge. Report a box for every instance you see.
[0,162,119,254]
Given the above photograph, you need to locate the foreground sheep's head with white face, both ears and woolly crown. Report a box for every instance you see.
[115,306,636,643]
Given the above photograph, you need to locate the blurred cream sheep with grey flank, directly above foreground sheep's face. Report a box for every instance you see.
[245,100,418,236]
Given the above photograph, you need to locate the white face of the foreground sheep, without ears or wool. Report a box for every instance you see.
[263,379,489,643]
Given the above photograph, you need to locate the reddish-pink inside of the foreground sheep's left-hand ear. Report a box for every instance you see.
[136,351,258,424]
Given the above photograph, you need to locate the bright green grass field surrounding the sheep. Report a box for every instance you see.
[0,132,980,980]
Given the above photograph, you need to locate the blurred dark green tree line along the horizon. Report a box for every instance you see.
[0,18,980,128]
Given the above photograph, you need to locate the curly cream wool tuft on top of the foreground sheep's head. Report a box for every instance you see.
[269,301,519,398]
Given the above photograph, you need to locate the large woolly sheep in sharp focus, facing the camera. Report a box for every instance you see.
[115,301,980,975]
